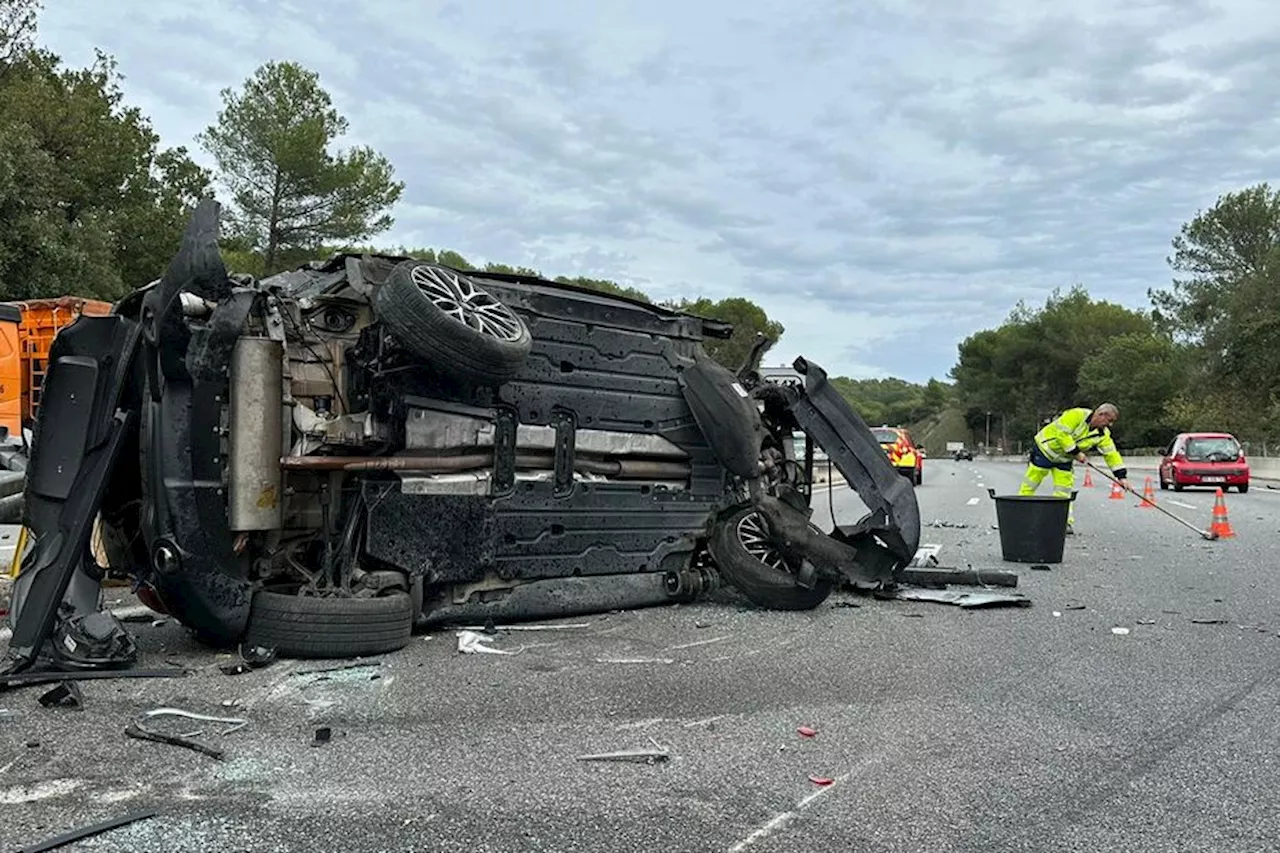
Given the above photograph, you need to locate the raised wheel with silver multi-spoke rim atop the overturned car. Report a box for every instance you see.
[372,261,532,384]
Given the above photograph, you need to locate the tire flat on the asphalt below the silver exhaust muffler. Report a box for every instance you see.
[244,589,413,658]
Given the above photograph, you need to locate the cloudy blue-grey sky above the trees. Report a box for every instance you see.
[41,0,1280,382]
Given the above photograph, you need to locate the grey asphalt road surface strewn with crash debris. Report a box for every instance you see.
[0,460,1280,853]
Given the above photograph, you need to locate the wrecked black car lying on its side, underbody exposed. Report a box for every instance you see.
[5,201,920,671]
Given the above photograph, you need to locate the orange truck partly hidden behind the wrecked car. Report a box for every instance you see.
[0,296,111,439]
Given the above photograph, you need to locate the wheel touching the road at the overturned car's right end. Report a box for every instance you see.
[707,506,832,610]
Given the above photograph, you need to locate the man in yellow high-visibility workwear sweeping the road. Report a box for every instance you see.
[1018,403,1130,533]
